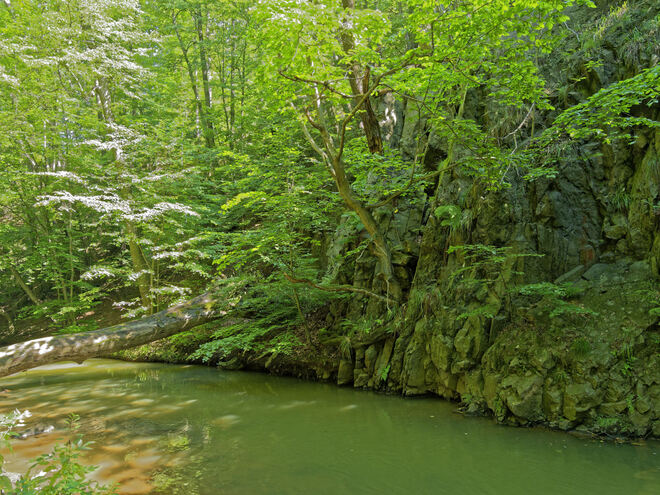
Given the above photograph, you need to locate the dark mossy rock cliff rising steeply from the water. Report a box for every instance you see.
[125,2,660,437]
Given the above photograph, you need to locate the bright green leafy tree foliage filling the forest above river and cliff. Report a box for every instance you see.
[0,0,660,392]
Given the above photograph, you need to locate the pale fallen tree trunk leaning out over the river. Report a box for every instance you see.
[0,293,225,377]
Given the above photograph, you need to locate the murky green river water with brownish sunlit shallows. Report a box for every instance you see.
[0,360,660,495]
